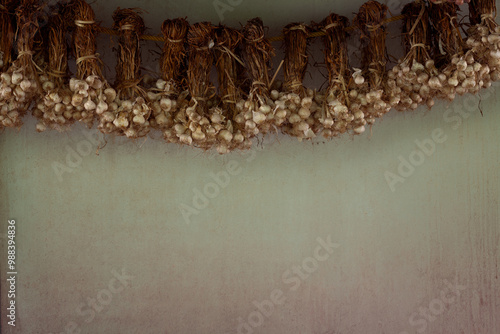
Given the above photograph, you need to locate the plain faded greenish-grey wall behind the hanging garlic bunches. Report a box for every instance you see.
[0,0,500,334]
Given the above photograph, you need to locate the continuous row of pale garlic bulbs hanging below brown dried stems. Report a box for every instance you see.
[0,1,500,153]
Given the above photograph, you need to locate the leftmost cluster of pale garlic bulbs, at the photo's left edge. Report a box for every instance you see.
[0,68,39,127]
